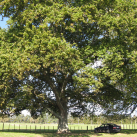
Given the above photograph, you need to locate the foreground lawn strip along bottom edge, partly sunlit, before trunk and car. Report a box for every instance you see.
[0,130,137,137]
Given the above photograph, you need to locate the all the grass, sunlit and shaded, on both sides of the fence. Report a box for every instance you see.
[0,123,137,137]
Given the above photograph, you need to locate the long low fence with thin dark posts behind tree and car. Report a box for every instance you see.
[0,123,137,132]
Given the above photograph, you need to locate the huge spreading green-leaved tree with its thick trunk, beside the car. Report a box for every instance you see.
[0,0,137,132]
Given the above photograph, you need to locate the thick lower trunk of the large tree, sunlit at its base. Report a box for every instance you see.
[58,113,70,133]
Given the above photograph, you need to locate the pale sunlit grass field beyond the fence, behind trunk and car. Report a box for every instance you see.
[0,123,137,131]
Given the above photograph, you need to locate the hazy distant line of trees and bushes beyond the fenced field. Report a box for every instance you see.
[0,114,137,125]
